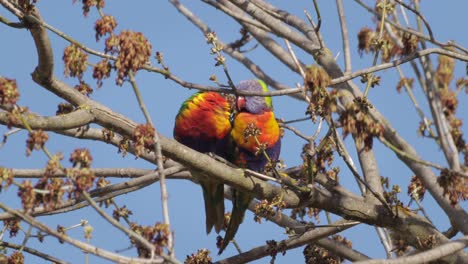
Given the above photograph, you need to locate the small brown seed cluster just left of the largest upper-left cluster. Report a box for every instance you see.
[62,44,88,80]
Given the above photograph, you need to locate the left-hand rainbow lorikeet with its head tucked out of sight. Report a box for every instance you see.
[174,92,231,233]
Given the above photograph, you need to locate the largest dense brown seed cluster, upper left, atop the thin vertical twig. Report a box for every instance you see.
[105,30,152,85]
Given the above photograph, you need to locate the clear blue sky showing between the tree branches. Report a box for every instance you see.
[0,0,468,263]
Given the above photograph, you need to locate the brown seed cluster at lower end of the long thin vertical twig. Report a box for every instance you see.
[130,223,169,258]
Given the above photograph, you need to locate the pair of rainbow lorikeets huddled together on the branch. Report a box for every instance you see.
[174,80,281,254]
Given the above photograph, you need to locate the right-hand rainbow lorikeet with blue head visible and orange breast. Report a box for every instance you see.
[219,80,281,254]
